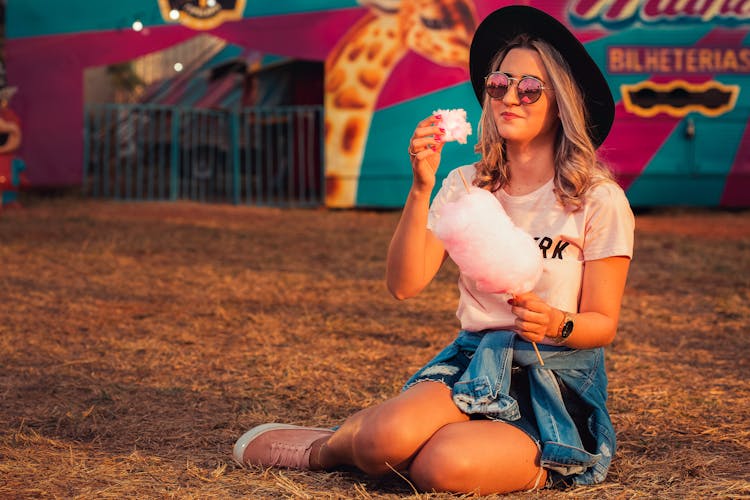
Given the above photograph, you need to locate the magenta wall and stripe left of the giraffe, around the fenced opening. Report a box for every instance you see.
[6,8,365,187]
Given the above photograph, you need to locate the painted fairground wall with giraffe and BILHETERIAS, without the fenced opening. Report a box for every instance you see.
[6,0,750,207]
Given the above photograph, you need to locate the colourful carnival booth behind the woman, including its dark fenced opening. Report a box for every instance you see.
[6,0,750,207]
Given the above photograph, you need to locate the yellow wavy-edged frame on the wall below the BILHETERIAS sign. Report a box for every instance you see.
[620,80,740,118]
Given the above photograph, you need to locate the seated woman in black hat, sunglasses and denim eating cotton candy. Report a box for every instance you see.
[235,6,633,494]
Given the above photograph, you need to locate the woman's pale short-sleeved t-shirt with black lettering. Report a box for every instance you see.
[427,165,635,338]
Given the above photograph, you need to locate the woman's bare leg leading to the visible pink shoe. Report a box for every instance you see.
[310,382,468,475]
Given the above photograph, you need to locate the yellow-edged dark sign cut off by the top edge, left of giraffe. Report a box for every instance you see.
[158,0,246,30]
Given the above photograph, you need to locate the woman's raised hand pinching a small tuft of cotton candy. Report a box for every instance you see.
[408,115,445,192]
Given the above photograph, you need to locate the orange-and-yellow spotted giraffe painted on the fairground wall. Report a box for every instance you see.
[324,0,477,208]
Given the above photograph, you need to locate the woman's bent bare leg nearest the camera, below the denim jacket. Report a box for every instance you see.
[409,420,547,495]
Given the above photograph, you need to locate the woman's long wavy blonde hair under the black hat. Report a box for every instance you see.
[474,35,613,210]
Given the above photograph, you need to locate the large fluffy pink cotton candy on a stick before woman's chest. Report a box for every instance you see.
[433,187,542,294]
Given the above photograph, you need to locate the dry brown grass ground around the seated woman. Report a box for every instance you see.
[0,199,750,499]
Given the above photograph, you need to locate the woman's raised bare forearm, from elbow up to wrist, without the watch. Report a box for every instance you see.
[386,187,442,299]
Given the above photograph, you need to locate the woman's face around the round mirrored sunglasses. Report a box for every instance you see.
[490,48,559,145]
